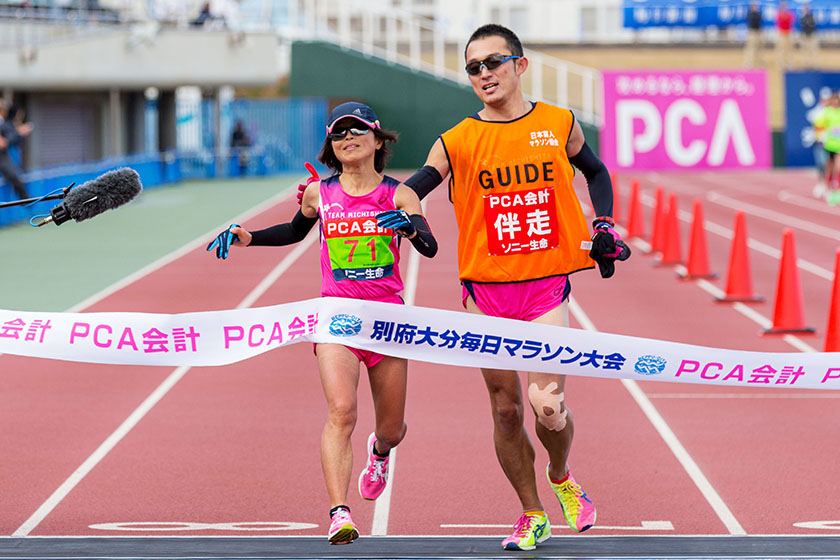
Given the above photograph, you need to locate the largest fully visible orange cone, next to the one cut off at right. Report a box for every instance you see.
[764,228,814,334]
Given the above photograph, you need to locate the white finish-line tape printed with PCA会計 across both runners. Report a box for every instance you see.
[0,298,840,389]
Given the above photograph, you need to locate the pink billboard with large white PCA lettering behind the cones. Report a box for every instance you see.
[600,70,772,170]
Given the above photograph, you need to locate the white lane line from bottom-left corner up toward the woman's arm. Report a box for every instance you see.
[12,221,318,537]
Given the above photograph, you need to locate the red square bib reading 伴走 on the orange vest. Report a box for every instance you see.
[484,187,560,256]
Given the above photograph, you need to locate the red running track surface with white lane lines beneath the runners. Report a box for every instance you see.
[0,168,840,536]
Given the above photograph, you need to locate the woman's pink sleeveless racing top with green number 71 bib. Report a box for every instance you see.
[318,175,403,303]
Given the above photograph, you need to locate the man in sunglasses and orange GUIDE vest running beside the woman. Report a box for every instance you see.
[405,24,630,550]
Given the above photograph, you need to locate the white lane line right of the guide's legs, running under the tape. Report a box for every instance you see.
[569,298,747,535]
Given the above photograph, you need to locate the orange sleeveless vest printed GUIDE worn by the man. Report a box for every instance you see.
[441,102,595,282]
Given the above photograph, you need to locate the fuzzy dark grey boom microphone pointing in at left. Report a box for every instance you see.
[38,167,143,227]
